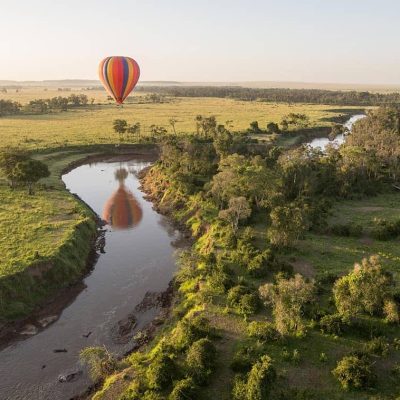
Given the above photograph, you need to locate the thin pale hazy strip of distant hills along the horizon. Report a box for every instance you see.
[0,79,400,92]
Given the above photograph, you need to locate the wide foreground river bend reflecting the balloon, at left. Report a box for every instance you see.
[0,155,181,400]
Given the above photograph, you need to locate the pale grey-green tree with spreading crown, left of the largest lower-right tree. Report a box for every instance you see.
[259,274,314,335]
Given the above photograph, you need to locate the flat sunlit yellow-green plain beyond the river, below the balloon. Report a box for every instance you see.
[0,88,366,150]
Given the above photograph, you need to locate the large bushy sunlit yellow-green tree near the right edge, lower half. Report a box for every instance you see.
[333,256,392,317]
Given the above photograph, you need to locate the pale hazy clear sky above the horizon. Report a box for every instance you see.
[0,0,400,84]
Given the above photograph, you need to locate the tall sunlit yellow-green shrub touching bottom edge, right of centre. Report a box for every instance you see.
[246,355,276,400]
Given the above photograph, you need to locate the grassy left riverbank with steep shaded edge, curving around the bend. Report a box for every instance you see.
[0,144,157,332]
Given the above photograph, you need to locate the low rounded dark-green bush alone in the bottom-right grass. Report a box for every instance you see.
[332,354,375,390]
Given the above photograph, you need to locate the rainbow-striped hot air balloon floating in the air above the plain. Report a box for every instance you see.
[99,57,140,104]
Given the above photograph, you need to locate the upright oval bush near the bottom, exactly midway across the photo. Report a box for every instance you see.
[186,339,216,385]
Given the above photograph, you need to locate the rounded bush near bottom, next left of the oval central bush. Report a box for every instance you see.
[146,353,176,390]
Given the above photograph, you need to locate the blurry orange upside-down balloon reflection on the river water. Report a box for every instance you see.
[102,169,143,229]
